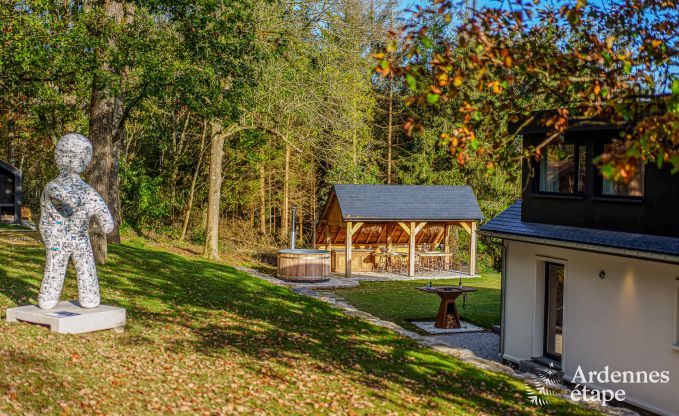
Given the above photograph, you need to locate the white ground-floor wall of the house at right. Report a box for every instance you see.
[504,240,679,415]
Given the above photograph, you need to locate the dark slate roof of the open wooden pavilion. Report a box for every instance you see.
[333,185,483,221]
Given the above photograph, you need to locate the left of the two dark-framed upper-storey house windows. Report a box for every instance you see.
[538,143,587,195]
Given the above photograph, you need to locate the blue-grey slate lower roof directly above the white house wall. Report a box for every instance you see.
[481,201,679,256]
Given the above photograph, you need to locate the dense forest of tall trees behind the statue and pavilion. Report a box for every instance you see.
[0,0,520,267]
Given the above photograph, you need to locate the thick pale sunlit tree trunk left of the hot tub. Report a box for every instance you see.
[203,121,225,260]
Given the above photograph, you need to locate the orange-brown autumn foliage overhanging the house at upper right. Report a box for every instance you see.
[375,0,679,180]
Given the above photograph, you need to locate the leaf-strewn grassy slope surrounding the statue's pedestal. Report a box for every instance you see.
[0,233,596,415]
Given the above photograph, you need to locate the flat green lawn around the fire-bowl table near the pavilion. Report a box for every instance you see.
[335,273,500,330]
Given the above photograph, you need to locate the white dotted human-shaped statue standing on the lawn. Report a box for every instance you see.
[38,134,113,309]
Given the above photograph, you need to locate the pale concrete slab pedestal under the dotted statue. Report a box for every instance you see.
[7,301,127,334]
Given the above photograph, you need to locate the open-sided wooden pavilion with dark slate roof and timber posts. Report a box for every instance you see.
[314,185,483,277]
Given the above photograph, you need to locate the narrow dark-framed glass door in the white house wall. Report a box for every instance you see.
[544,263,564,361]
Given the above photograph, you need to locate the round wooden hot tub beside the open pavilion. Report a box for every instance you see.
[278,249,330,282]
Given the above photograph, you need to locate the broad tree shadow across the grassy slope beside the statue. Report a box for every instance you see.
[0,245,596,414]
